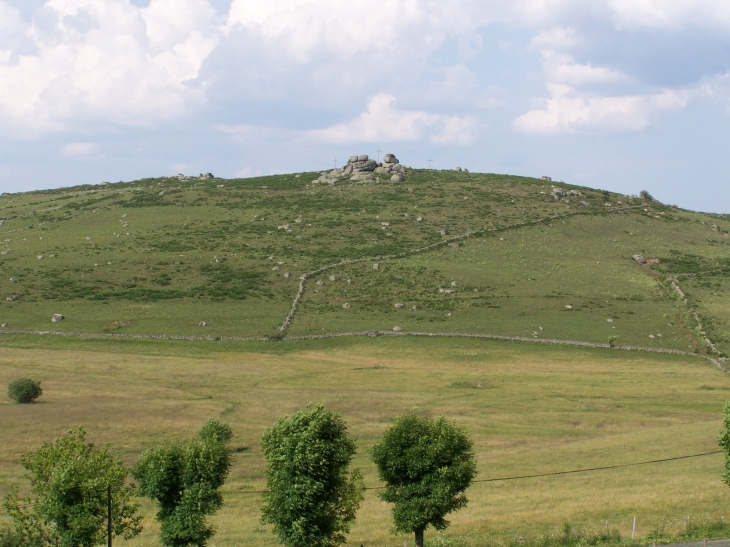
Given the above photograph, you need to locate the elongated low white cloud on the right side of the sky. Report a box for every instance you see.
[512,84,692,135]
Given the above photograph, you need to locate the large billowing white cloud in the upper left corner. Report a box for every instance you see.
[0,0,219,133]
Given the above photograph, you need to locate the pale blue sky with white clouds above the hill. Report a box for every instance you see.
[0,0,730,213]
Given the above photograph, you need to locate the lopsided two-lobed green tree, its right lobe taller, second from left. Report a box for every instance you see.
[132,419,232,547]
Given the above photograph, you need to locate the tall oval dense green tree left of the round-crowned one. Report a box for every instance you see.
[261,404,364,547]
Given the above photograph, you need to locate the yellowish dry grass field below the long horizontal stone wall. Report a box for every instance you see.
[0,335,730,547]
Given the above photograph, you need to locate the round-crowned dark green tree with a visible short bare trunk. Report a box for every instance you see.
[371,413,476,547]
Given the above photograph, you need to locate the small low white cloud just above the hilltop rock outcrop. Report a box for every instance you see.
[304,94,477,146]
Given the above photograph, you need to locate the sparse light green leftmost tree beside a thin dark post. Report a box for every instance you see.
[5,428,142,547]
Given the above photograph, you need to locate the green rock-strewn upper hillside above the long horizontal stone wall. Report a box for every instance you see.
[0,170,730,352]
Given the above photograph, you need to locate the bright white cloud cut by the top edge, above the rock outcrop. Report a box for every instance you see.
[222,0,484,62]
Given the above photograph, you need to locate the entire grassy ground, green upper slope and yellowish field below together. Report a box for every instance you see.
[0,170,730,547]
